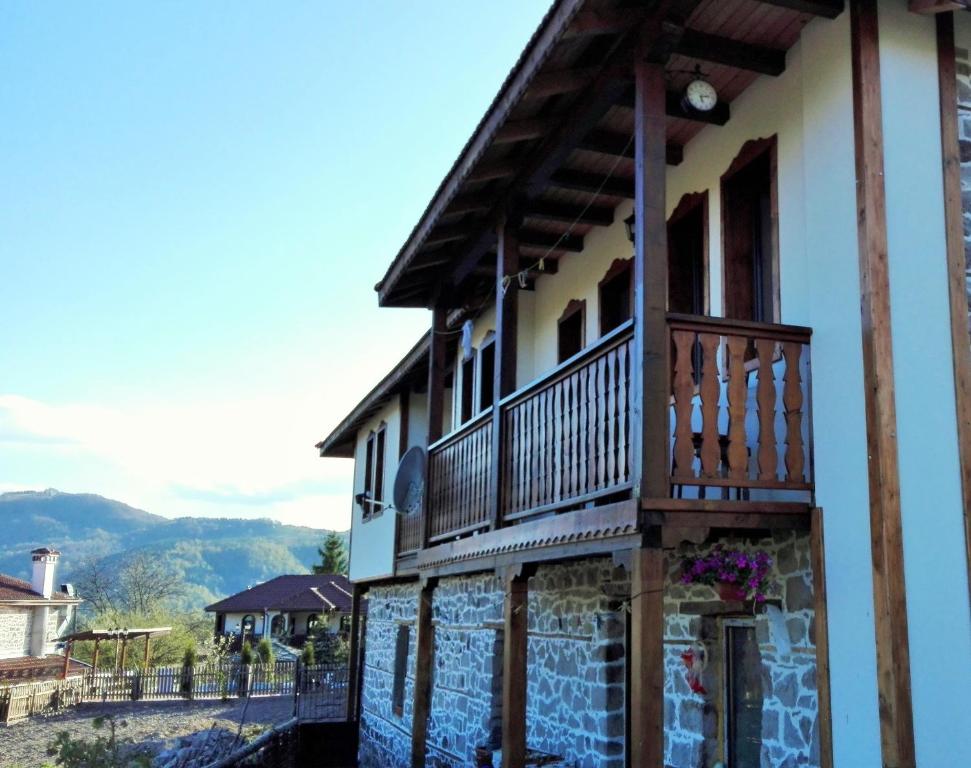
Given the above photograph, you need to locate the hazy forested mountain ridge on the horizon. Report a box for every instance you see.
[0,489,346,609]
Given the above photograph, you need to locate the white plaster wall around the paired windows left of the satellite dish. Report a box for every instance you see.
[350,398,401,581]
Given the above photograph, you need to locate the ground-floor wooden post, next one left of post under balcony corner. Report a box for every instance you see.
[502,568,529,768]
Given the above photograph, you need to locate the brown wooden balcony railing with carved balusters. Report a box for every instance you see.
[398,315,813,556]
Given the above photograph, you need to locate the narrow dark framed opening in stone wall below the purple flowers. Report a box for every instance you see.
[723,619,762,768]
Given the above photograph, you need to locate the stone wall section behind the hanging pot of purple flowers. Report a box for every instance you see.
[664,533,819,768]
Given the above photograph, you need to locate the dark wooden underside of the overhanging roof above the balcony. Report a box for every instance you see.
[379,0,841,304]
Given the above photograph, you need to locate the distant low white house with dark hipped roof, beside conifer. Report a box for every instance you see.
[206,573,351,645]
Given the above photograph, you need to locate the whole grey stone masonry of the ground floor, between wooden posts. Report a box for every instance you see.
[360,533,819,768]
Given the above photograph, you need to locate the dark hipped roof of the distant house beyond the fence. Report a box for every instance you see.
[206,573,351,613]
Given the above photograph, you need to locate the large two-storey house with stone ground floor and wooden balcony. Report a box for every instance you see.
[318,0,971,768]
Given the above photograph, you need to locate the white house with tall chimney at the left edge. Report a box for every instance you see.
[0,547,81,684]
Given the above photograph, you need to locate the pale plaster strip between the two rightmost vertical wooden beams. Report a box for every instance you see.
[879,2,971,766]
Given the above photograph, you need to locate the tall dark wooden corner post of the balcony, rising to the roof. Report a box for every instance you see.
[631,53,671,499]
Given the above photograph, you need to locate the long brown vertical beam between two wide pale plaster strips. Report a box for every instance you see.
[850,0,916,768]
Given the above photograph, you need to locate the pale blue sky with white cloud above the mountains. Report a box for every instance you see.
[0,0,548,529]
